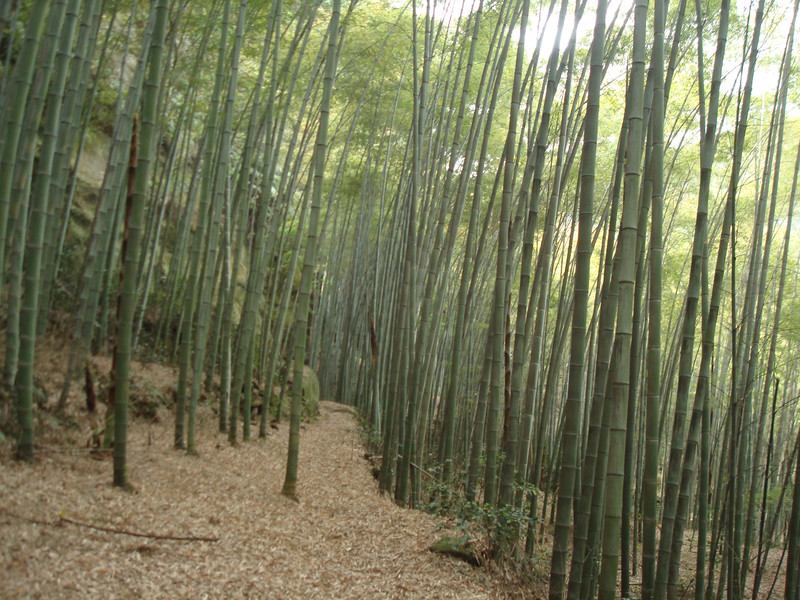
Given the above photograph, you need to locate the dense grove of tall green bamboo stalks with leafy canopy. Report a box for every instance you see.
[0,0,800,600]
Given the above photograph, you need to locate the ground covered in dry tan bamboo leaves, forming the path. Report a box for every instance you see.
[0,342,540,599]
